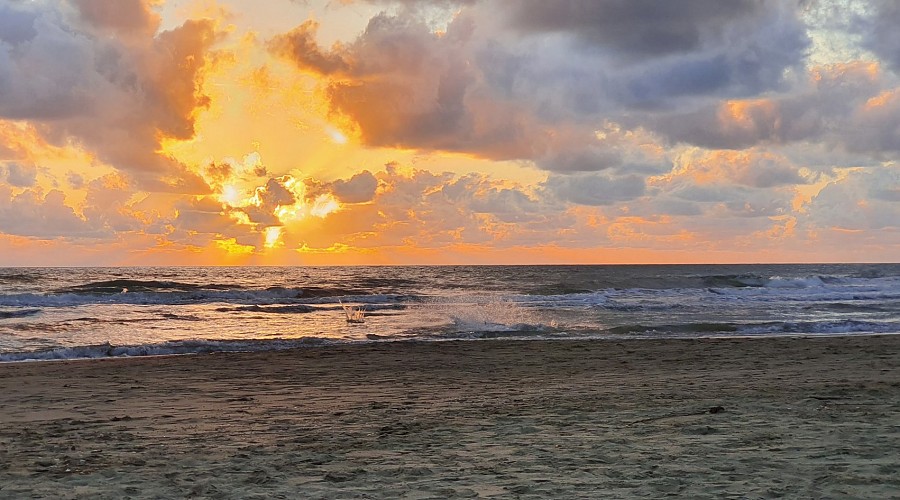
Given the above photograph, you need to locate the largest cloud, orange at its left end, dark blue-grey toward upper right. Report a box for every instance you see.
[269,0,808,176]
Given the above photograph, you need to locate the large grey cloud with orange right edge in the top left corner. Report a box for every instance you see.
[0,0,221,192]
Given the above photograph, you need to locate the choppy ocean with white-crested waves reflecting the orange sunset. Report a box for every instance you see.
[0,264,900,362]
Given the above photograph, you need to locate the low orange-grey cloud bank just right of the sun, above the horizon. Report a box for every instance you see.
[285,163,571,249]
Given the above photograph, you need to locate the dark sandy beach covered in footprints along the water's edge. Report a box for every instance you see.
[0,336,900,499]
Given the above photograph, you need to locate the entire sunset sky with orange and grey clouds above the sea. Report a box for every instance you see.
[0,0,900,266]
